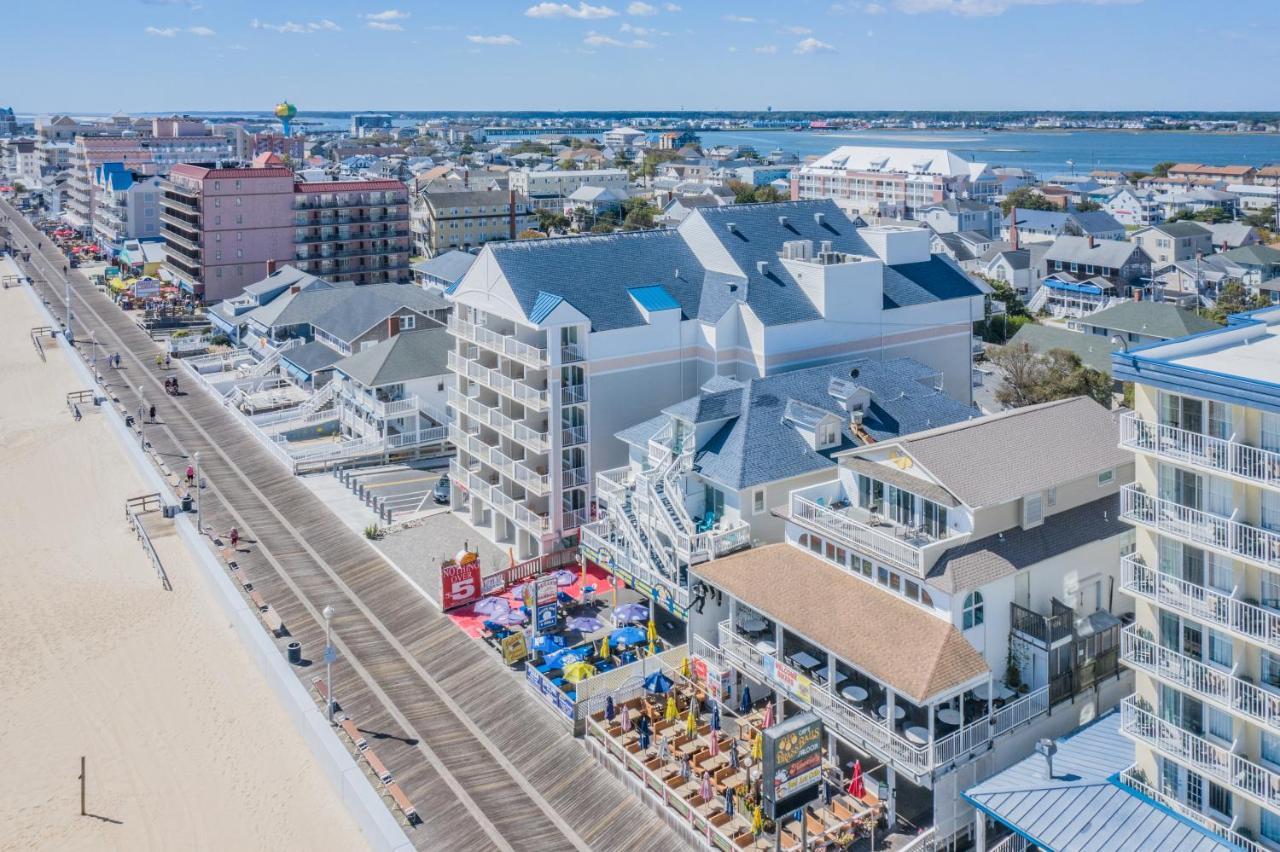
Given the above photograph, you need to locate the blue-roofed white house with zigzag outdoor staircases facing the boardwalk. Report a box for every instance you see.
[581,358,978,619]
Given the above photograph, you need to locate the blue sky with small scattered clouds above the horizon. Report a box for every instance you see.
[10,0,1280,113]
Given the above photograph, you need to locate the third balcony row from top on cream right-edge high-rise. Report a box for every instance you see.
[1120,556,1280,647]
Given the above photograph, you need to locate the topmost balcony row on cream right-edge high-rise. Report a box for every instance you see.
[1120,413,1280,489]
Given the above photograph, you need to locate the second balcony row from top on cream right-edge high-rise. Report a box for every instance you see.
[1120,485,1280,568]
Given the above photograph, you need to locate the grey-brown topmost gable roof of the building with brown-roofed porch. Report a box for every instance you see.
[870,397,1132,509]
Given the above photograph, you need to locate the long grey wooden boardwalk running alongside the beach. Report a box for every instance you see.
[0,202,687,852]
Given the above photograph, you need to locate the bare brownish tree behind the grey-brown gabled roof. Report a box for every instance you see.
[988,344,1112,408]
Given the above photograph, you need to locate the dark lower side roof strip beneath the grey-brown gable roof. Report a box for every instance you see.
[928,494,1129,594]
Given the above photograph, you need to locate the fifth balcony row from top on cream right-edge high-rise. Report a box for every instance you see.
[1120,696,1280,809]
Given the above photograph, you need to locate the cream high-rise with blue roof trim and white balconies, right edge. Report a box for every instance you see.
[1112,308,1280,849]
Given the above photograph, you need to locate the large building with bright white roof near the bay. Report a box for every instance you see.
[791,145,997,219]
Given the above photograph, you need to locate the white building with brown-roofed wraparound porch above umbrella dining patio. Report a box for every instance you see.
[689,397,1133,848]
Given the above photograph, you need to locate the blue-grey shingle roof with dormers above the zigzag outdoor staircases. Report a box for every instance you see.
[640,358,978,490]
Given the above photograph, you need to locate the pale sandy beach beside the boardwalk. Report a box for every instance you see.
[0,273,366,849]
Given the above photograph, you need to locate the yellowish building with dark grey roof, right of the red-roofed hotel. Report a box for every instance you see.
[413,189,536,257]
